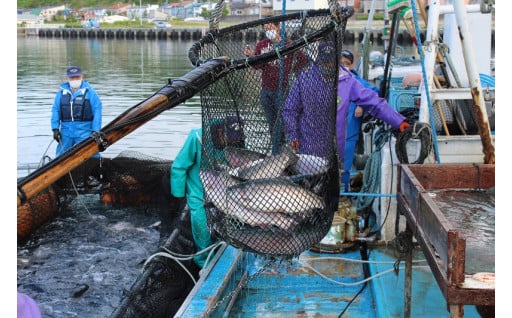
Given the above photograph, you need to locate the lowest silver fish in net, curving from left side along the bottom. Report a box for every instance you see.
[199,170,299,231]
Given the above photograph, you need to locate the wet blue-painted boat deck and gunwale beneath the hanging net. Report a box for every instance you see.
[175,246,480,318]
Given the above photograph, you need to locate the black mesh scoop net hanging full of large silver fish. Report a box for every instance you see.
[189,2,353,259]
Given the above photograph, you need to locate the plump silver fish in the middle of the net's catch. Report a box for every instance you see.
[228,178,325,219]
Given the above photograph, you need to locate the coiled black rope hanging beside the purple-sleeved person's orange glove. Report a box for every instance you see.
[395,122,432,164]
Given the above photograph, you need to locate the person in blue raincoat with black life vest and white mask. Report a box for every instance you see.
[51,66,102,158]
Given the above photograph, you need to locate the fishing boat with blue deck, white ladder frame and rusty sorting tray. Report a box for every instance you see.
[175,1,495,317]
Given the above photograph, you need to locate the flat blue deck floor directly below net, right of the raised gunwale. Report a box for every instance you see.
[233,251,378,317]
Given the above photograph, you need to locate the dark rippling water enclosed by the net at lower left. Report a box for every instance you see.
[17,195,160,318]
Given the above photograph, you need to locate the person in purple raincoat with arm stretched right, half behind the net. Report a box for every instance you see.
[282,41,409,162]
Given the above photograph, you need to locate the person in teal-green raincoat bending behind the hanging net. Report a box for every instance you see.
[170,116,245,268]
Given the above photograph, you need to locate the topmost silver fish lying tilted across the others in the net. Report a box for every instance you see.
[238,146,299,180]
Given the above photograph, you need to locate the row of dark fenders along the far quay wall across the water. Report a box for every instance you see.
[18,27,495,47]
